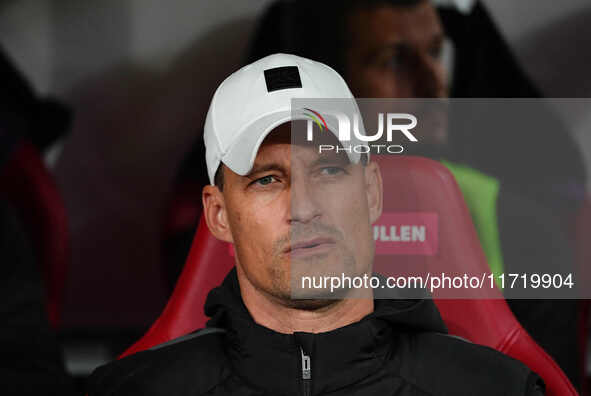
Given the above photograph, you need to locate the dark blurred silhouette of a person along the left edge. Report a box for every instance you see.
[0,51,74,396]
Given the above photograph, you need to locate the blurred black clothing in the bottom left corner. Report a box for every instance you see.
[0,201,74,396]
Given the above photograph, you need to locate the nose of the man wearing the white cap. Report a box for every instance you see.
[289,176,321,223]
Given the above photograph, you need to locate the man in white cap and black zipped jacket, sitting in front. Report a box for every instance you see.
[89,54,543,396]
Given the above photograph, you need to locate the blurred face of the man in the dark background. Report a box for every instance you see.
[345,1,448,147]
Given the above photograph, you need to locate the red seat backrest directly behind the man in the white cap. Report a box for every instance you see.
[123,156,577,396]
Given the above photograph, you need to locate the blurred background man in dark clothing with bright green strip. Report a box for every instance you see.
[249,0,584,385]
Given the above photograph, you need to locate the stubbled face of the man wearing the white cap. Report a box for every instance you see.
[210,123,381,306]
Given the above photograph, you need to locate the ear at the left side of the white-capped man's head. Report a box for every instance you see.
[201,185,234,243]
